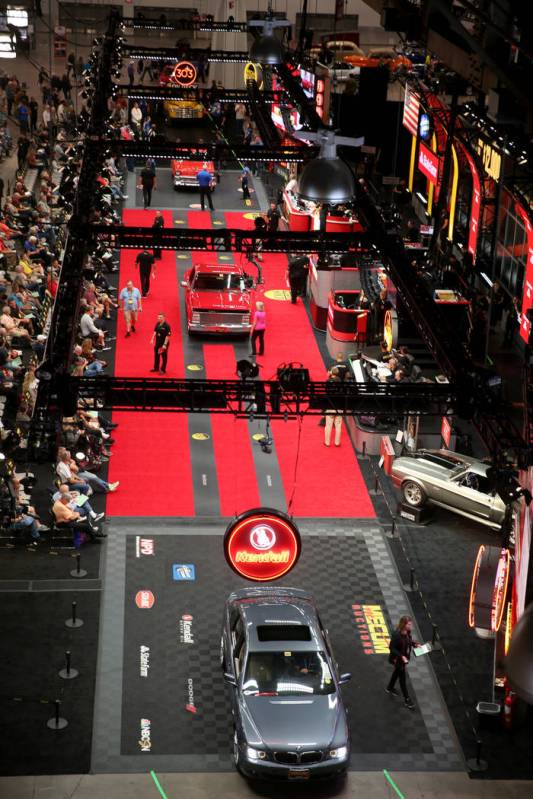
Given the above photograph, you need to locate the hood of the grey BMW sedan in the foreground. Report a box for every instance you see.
[241,694,344,750]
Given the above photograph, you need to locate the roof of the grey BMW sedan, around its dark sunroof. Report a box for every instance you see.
[239,597,324,652]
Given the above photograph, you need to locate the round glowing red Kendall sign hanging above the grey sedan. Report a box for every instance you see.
[224,508,302,582]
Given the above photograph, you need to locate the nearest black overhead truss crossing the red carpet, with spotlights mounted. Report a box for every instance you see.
[69,377,456,418]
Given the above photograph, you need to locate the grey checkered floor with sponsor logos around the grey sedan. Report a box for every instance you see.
[92,517,463,773]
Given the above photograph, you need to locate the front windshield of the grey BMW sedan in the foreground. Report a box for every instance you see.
[243,650,335,696]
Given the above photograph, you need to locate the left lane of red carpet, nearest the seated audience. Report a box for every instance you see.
[107,209,194,516]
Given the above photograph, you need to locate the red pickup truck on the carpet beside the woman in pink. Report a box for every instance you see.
[181,264,253,335]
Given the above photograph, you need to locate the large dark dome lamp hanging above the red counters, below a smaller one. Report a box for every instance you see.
[292,128,365,205]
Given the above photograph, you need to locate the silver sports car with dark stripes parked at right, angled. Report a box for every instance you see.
[392,449,505,530]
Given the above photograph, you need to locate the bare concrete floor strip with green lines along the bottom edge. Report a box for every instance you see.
[0,772,533,799]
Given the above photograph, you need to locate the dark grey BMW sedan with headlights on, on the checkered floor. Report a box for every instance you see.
[220,586,351,780]
